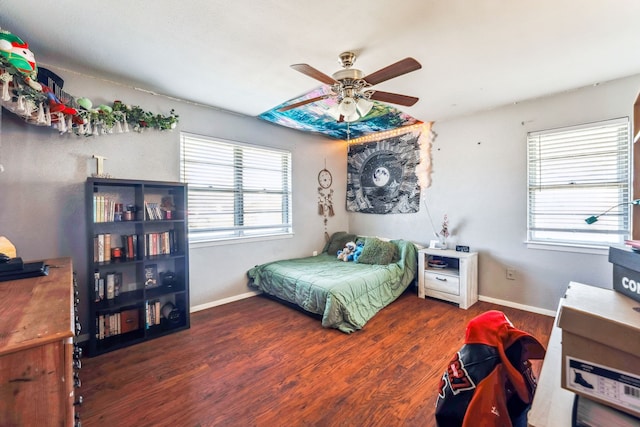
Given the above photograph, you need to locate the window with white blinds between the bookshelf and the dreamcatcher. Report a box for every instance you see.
[180,133,292,242]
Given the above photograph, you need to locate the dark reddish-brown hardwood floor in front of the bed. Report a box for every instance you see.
[79,287,553,427]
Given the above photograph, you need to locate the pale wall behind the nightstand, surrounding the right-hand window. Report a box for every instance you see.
[349,76,640,312]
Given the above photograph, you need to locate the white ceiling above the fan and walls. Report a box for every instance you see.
[0,0,640,121]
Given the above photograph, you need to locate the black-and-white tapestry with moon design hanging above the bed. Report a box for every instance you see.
[347,127,421,214]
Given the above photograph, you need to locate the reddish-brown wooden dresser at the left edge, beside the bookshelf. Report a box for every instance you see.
[0,258,75,426]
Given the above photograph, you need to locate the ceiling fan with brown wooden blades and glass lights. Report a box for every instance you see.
[278,52,422,122]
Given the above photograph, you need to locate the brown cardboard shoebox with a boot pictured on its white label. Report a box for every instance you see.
[558,282,640,416]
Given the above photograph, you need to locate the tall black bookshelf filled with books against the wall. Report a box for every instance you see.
[85,178,190,356]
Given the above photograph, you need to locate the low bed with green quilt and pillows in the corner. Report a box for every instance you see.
[247,232,417,333]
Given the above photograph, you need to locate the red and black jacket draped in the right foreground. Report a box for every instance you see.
[436,310,545,427]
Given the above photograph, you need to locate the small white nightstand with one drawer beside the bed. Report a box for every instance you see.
[418,248,478,310]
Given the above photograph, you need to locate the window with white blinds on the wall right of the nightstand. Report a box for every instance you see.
[527,118,631,246]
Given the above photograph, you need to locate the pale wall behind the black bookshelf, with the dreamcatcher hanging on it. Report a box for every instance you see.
[0,67,348,324]
